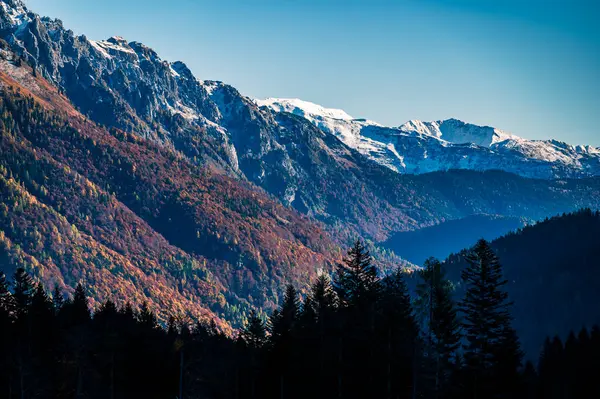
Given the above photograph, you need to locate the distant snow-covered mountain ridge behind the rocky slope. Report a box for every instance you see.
[257,98,600,179]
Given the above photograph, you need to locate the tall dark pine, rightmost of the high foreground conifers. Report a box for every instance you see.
[461,240,522,398]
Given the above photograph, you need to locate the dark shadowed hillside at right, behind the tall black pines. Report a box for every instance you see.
[445,210,600,359]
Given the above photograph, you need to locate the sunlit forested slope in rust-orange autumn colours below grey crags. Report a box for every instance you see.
[0,51,338,326]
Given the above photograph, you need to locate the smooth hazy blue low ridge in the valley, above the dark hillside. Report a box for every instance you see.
[381,215,527,265]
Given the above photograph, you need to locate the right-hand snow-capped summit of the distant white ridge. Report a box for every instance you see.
[399,119,519,147]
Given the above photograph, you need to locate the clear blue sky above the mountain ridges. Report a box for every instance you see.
[26,0,600,146]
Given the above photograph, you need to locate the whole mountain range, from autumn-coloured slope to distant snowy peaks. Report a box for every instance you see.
[0,0,600,328]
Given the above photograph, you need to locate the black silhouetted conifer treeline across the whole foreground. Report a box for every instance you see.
[0,240,600,399]
